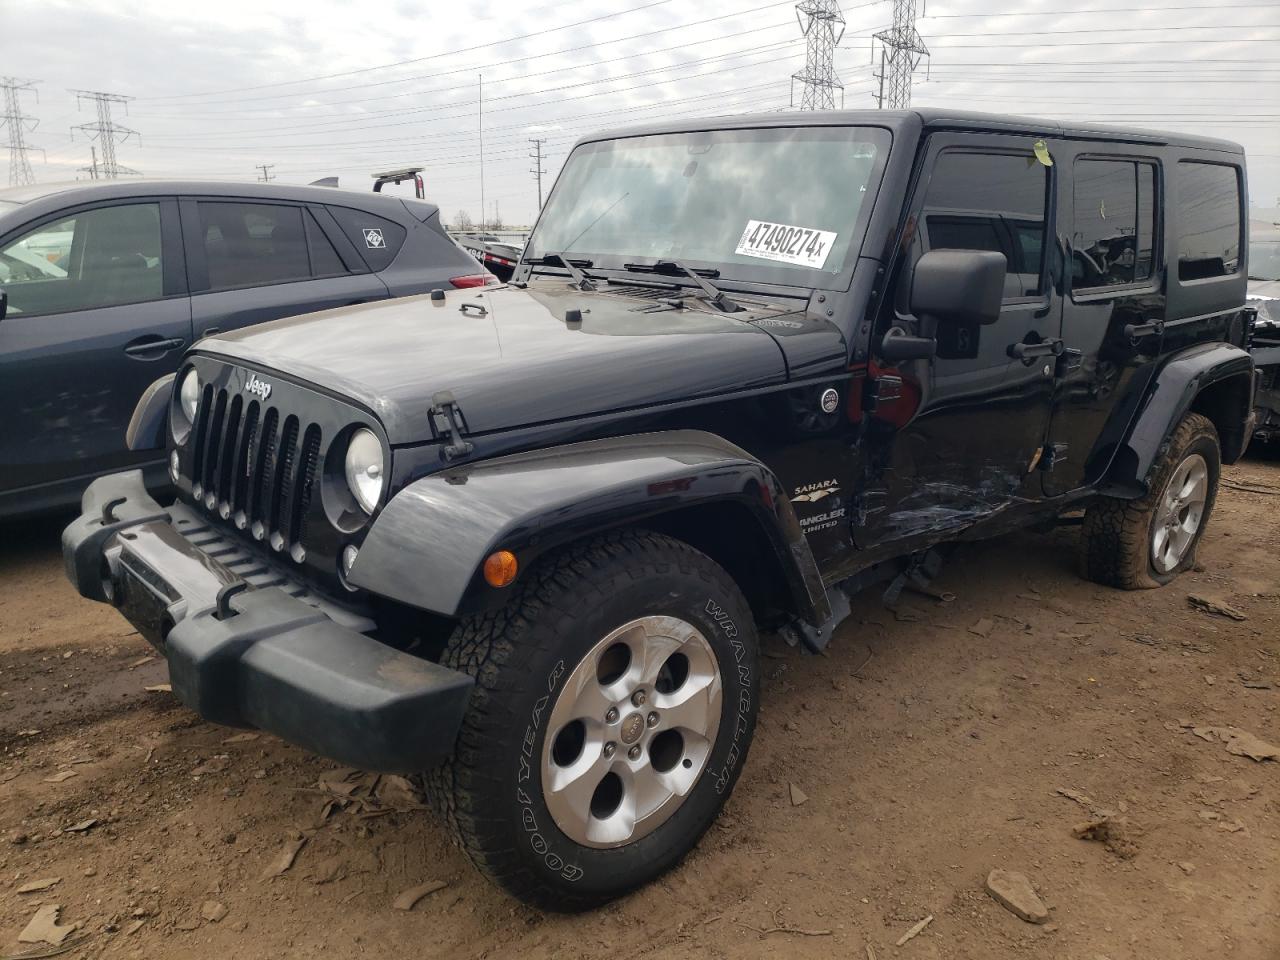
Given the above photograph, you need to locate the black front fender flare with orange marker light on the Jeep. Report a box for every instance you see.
[347,430,831,626]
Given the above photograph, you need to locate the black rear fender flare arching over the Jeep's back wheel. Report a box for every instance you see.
[1102,343,1253,497]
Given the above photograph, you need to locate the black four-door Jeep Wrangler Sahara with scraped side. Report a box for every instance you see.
[63,111,1254,910]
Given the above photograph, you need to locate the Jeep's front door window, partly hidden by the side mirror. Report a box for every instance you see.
[922,150,1048,300]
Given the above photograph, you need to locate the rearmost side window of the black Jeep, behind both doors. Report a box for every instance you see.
[1178,160,1240,280]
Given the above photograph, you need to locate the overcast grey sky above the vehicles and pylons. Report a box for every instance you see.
[0,0,1280,224]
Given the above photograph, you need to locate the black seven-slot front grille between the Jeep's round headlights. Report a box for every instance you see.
[191,384,323,562]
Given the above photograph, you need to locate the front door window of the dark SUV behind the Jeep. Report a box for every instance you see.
[0,204,164,316]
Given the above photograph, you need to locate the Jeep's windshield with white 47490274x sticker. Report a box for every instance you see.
[525,127,890,287]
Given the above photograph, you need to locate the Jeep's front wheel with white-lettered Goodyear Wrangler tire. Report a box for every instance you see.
[426,532,758,911]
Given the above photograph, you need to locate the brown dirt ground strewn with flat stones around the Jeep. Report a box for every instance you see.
[0,458,1280,960]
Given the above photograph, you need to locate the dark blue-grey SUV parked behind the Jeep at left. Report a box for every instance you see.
[0,180,486,517]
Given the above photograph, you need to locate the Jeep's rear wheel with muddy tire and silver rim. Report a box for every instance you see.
[1083,413,1221,590]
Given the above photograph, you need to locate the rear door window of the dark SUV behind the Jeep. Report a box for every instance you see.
[198,201,311,291]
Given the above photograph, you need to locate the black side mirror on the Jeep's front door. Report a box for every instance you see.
[911,250,1009,326]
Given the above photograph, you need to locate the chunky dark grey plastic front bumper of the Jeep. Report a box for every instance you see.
[63,470,472,773]
